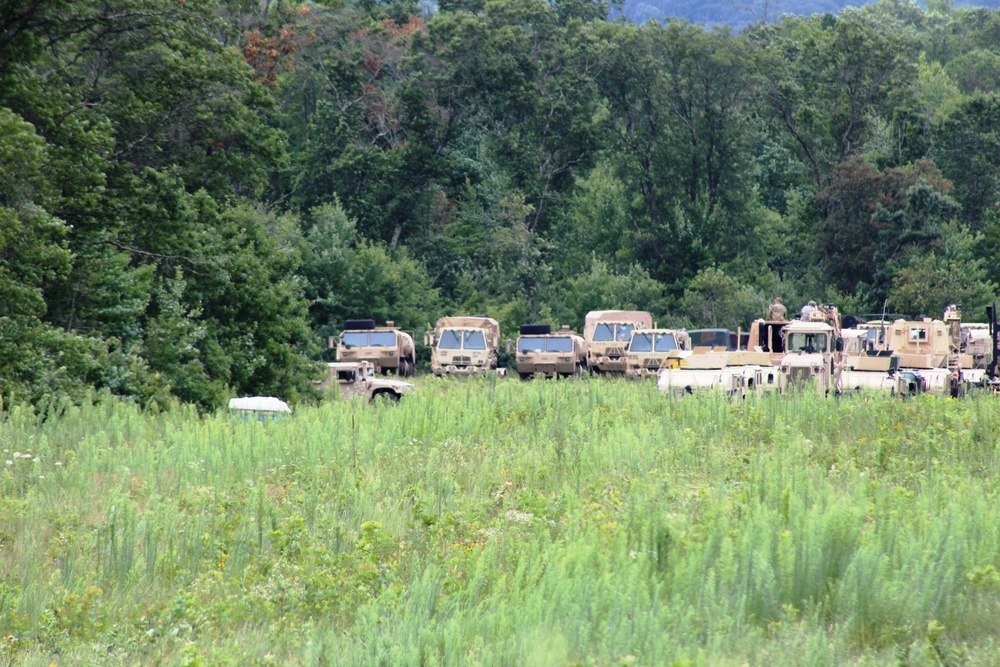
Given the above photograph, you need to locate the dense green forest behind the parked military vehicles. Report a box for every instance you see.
[0,0,1000,407]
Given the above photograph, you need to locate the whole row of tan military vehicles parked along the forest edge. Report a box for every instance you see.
[308,306,1000,401]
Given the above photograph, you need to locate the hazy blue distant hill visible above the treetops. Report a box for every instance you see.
[612,0,1000,28]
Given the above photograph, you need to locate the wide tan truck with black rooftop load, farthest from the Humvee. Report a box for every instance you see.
[515,324,587,380]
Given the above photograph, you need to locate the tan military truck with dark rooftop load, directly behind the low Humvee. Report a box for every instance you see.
[330,320,415,377]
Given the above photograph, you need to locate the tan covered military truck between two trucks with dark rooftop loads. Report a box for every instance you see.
[424,317,506,376]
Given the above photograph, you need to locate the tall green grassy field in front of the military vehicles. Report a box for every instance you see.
[0,378,1000,666]
